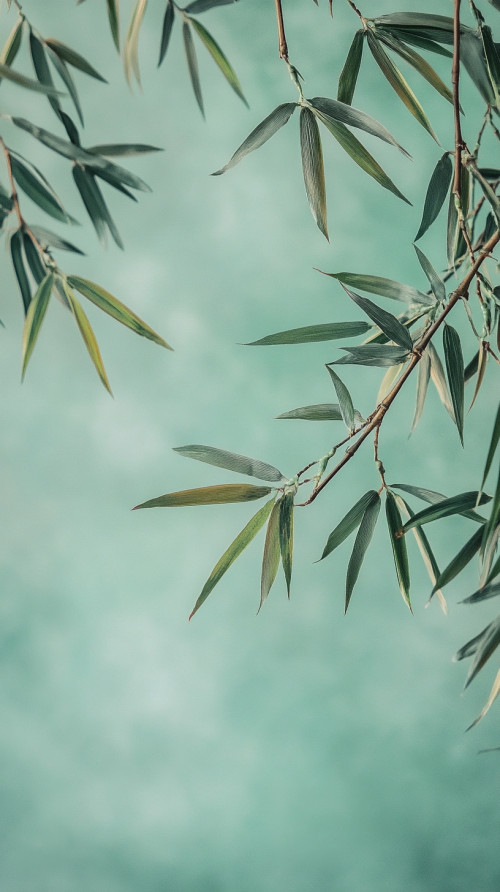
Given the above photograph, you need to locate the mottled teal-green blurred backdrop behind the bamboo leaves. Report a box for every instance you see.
[0,0,500,892]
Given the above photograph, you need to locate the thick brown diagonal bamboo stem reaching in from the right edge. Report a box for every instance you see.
[304,232,500,505]
